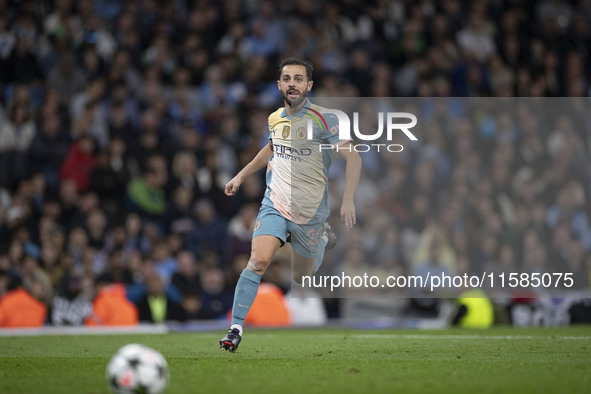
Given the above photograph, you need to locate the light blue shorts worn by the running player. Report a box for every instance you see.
[252,205,324,258]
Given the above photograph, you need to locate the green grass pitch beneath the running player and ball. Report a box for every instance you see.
[0,326,591,394]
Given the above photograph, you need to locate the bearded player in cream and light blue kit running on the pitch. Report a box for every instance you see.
[220,58,361,352]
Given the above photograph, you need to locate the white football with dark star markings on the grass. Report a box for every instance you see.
[107,343,170,394]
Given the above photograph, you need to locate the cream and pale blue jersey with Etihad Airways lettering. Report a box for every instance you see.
[263,100,350,224]
